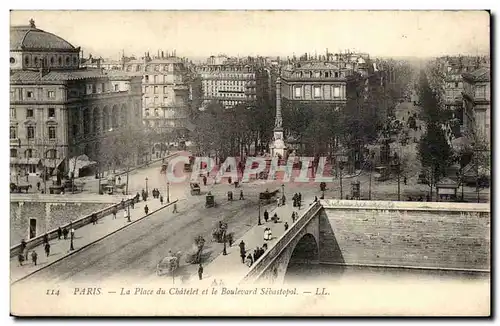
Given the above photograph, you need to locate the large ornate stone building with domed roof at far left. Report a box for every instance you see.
[10,20,141,175]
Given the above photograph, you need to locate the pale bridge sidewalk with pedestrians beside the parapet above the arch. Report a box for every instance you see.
[192,196,314,286]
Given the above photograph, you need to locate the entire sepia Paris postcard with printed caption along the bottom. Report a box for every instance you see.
[9,10,491,317]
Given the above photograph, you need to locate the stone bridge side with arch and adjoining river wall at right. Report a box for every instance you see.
[242,200,490,284]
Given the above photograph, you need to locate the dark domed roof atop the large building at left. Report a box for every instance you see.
[10,20,77,51]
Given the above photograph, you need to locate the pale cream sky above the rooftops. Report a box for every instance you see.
[10,11,490,59]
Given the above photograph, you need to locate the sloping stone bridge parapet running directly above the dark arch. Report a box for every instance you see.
[240,202,322,284]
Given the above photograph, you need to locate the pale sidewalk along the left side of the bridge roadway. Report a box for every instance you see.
[10,197,176,283]
